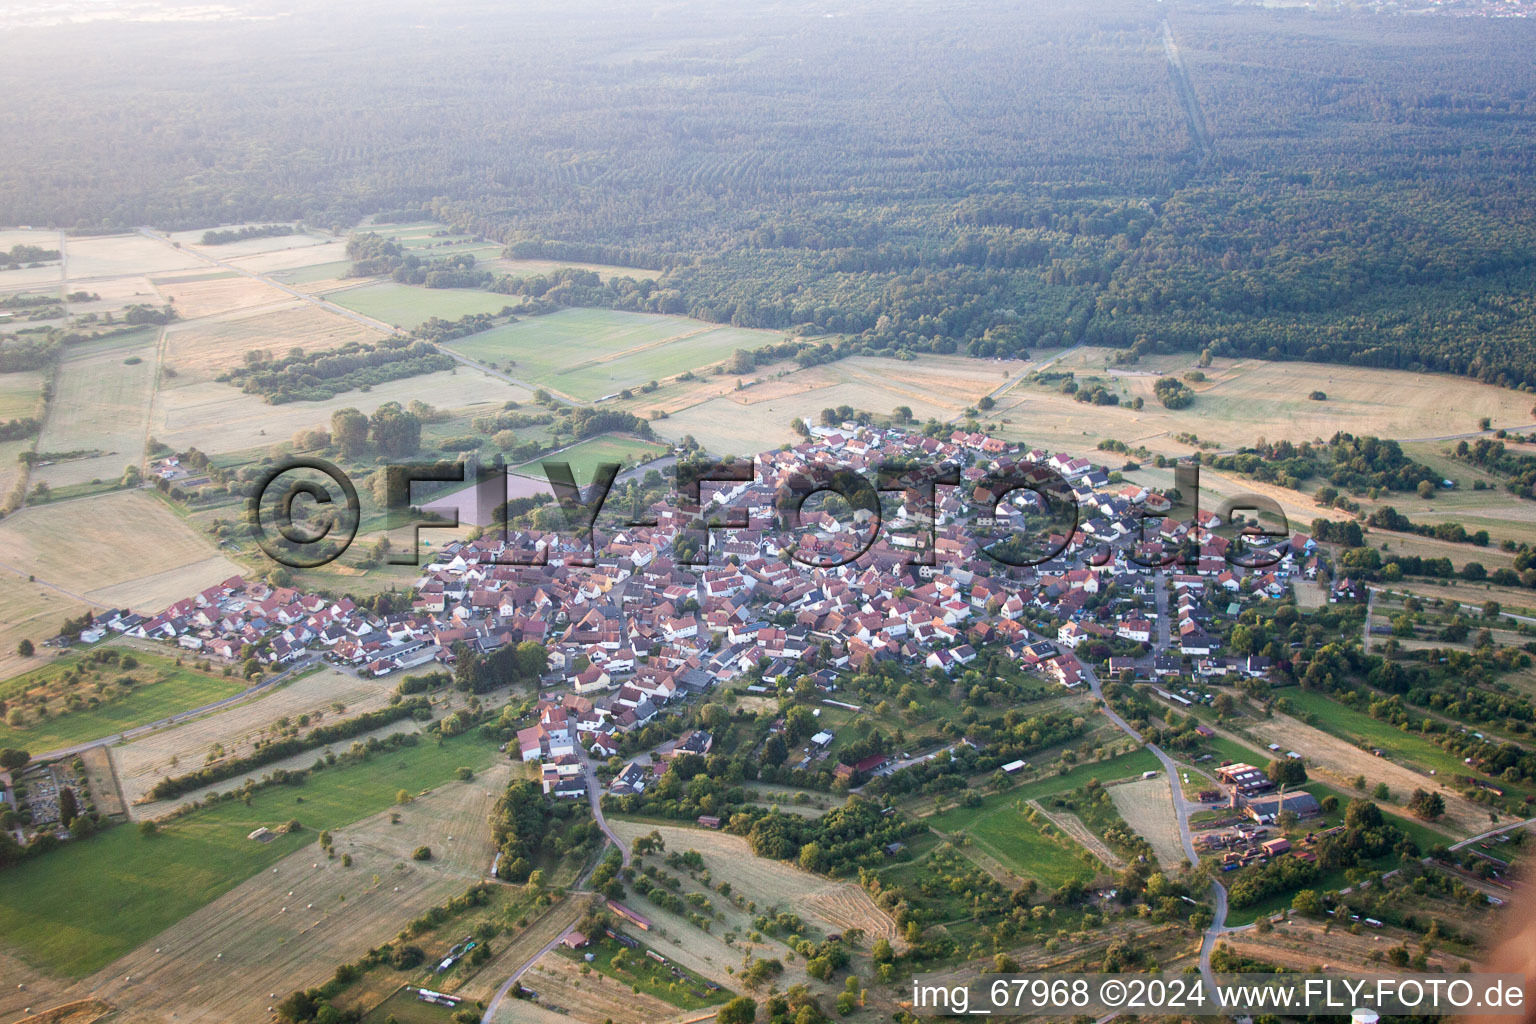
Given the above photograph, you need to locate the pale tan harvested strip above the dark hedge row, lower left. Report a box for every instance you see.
[112,668,395,809]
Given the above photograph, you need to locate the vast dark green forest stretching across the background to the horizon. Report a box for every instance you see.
[0,0,1536,383]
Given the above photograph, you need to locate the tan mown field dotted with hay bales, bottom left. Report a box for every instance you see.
[69,765,507,1024]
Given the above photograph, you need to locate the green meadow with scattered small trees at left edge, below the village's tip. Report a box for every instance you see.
[0,645,246,754]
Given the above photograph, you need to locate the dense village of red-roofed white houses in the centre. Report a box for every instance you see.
[109,424,1316,789]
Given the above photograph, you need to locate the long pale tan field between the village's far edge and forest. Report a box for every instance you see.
[657,356,1028,454]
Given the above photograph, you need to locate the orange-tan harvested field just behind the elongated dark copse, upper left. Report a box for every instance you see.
[166,303,382,388]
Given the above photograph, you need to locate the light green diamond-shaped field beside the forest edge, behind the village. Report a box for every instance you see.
[447,309,782,402]
